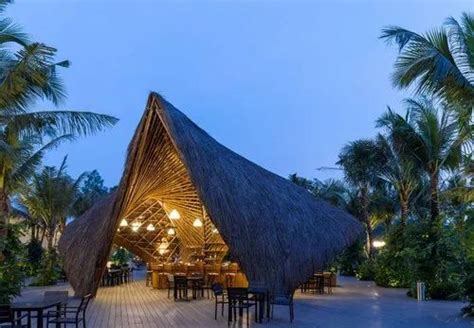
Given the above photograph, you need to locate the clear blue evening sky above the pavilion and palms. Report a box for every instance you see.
[7,0,474,186]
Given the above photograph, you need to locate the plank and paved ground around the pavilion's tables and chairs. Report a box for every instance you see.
[13,277,474,328]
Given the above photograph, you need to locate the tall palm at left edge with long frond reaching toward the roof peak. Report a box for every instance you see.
[0,0,117,258]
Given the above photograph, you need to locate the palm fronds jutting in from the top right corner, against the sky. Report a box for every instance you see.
[381,13,474,108]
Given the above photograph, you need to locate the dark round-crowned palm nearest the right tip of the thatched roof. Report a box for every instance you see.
[337,139,383,256]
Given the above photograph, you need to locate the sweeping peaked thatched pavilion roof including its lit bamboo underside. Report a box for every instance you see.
[60,93,362,294]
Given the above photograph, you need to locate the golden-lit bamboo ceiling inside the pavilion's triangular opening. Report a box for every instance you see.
[114,96,227,262]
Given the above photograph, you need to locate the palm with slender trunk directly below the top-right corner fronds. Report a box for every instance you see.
[377,98,469,223]
